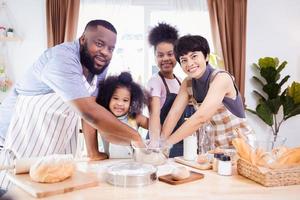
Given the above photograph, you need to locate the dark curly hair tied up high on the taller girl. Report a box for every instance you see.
[148,23,178,49]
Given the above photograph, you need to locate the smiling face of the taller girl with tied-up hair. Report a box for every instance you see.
[155,42,176,74]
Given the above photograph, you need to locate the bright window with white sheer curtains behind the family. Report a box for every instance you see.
[77,0,213,85]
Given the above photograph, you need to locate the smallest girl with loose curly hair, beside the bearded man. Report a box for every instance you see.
[96,72,148,158]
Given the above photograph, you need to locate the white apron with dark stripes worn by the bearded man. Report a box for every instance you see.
[0,74,96,188]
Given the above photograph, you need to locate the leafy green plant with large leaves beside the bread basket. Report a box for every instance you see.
[246,57,300,145]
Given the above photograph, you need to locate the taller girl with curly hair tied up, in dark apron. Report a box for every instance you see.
[147,23,193,157]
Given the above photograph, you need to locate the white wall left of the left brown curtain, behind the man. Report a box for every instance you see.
[0,0,47,101]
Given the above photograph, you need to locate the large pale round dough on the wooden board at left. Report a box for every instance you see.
[29,154,75,183]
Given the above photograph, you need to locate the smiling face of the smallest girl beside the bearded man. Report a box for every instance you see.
[109,87,131,117]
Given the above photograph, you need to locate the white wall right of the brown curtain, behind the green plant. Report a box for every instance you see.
[246,0,300,146]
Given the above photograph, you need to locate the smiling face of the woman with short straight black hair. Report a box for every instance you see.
[179,51,208,79]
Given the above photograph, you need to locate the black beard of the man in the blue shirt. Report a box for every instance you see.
[80,43,109,74]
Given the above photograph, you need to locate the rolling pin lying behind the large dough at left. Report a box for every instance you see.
[0,157,39,174]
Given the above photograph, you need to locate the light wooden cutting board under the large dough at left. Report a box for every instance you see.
[8,170,98,198]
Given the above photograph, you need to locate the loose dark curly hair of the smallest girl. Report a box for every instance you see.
[96,72,149,118]
